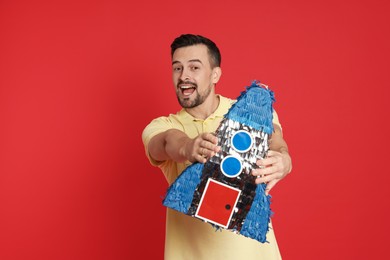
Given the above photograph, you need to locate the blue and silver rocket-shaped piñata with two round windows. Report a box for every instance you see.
[163,81,275,243]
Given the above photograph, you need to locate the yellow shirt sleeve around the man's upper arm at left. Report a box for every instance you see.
[142,117,172,166]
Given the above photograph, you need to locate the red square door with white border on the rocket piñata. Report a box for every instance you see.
[195,179,241,228]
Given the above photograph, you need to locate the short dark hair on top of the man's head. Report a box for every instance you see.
[171,34,221,68]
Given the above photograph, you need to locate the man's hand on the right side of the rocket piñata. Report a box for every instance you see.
[252,150,292,195]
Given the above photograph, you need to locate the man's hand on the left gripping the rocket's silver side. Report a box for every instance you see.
[184,133,221,163]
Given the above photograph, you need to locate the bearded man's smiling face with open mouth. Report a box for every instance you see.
[172,44,218,108]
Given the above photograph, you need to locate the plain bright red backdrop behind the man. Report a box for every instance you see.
[0,0,390,260]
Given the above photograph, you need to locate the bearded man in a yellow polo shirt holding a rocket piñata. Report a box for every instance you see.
[142,34,291,260]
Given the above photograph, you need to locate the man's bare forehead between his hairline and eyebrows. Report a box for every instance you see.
[172,44,209,64]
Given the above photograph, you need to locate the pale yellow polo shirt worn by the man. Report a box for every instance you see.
[142,96,281,260]
